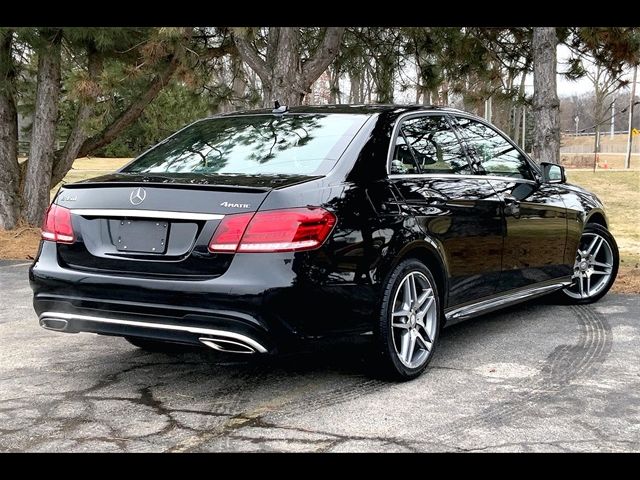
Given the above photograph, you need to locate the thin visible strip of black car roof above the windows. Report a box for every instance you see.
[215,104,464,117]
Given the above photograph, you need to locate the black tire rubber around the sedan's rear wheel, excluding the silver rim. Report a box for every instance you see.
[376,259,442,381]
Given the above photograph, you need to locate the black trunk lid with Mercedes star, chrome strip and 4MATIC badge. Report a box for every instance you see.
[55,173,318,279]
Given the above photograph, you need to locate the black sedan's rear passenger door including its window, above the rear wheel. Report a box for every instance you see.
[389,113,503,307]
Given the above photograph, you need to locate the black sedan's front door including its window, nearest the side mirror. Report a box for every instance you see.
[455,116,567,291]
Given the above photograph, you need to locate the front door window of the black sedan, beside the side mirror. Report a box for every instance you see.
[457,118,533,180]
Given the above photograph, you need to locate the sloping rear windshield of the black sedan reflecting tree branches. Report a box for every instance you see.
[122,113,367,175]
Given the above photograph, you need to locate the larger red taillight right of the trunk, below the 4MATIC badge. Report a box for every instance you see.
[209,207,336,253]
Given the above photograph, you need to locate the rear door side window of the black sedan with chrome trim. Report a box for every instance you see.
[391,115,472,175]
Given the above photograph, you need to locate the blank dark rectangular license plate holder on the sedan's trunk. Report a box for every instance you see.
[114,219,169,254]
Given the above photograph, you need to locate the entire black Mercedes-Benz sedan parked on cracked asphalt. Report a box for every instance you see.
[30,105,619,379]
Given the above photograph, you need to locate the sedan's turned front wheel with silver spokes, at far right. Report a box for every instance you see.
[557,223,620,305]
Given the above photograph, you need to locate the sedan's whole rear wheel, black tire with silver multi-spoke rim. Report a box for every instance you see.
[374,259,443,381]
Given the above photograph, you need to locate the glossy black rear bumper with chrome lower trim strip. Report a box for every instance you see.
[29,241,376,353]
